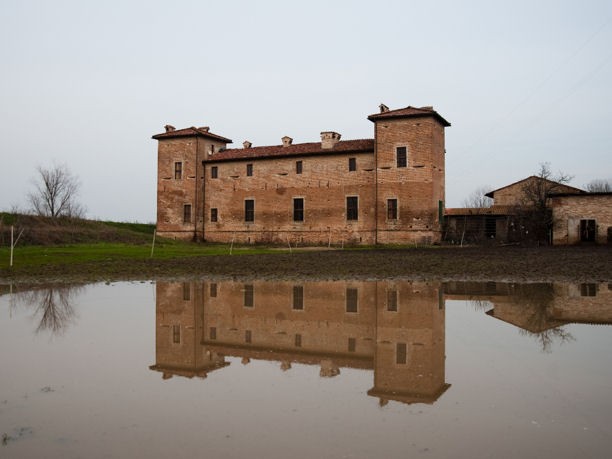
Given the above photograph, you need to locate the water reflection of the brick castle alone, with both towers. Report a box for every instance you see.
[151,281,449,403]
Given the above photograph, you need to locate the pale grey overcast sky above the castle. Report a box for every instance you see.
[0,0,612,222]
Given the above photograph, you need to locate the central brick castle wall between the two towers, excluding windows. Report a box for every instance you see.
[204,153,375,245]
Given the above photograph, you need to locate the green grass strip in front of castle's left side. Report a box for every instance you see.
[0,242,279,270]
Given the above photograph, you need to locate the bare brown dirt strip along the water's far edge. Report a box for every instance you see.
[0,246,612,283]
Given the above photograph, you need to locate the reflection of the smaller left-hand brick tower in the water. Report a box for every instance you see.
[149,282,229,379]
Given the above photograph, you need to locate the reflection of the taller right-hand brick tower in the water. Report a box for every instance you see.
[368,282,450,404]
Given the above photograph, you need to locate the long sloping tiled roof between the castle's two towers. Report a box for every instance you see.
[209,139,374,162]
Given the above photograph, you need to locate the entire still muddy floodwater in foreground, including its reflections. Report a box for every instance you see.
[0,281,612,458]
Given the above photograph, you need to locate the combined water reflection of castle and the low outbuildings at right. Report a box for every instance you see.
[151,281,612,403]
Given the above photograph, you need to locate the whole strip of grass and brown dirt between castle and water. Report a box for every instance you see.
[0,243,612,283]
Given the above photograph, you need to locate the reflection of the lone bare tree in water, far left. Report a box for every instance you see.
[14,284,84,335]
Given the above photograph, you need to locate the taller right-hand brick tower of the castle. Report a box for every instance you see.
[368,105,450,244]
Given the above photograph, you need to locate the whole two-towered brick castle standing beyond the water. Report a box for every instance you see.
[153,105,450,244]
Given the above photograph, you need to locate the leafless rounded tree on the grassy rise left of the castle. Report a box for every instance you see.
[28,164,85,218]
